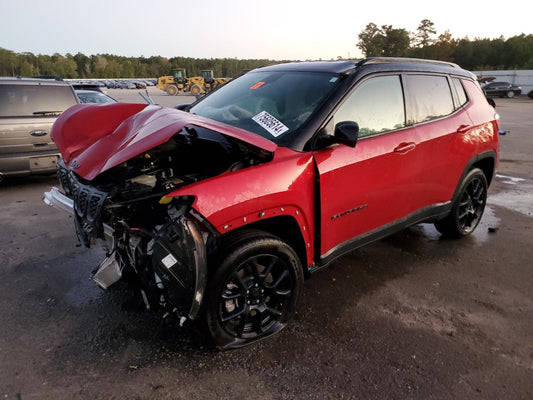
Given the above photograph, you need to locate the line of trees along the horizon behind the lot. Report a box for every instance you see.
[0,19,533,79]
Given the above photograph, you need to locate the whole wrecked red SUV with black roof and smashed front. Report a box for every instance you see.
[45,58,498,347]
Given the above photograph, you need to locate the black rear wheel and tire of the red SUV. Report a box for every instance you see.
[435,168,488,238]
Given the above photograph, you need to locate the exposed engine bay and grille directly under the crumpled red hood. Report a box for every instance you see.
[58,127,268,247]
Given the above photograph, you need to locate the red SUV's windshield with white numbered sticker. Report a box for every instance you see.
[190,71,339,144]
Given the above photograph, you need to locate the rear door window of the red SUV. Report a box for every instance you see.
[405,75,454,125]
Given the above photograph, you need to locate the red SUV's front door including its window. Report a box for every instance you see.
[315,75,419,261]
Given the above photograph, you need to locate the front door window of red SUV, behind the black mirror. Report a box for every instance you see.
[333,75,405,138]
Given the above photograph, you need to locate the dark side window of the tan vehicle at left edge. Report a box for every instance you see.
[0,85,77,117]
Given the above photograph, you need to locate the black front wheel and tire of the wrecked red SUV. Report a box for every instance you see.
[206,231,303,349]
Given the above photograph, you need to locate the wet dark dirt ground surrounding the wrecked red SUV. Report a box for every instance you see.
[0,89,533,400]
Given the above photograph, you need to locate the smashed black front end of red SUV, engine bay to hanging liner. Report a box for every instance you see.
[45,108,272,323]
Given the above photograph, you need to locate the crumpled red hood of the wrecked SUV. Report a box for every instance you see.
[51,103,277,180]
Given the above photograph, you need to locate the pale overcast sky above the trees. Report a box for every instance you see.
[0,0,533,60]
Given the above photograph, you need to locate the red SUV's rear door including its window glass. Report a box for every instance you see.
[403,73,476,208]
